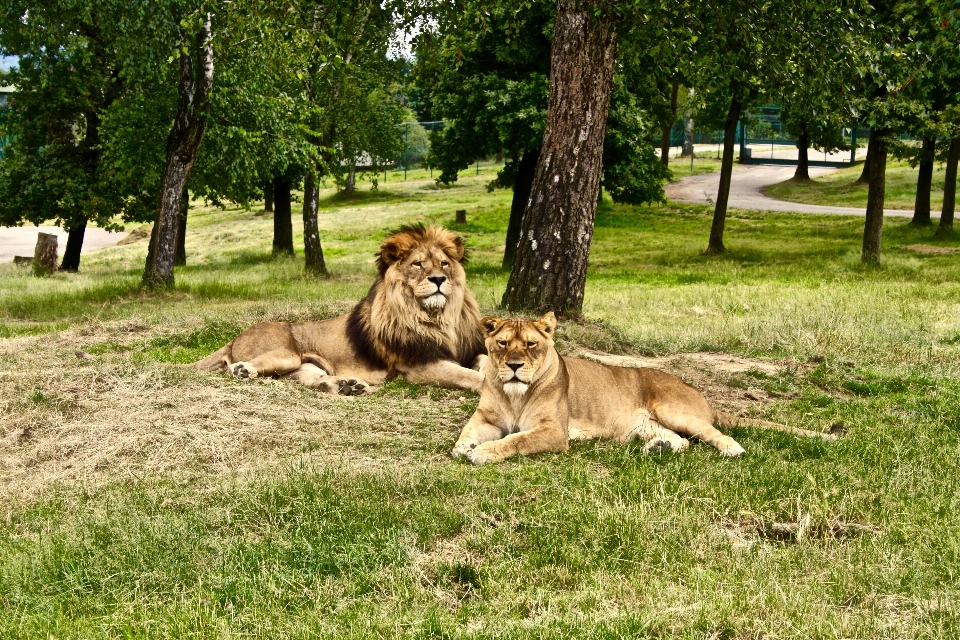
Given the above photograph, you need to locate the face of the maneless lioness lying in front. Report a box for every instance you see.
[480,311,557,396]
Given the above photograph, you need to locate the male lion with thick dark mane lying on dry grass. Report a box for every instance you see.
[193,225,484,395]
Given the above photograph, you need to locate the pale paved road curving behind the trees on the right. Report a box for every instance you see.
[664,164,913,217]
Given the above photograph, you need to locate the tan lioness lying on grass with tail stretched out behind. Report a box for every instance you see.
[453,313,836,464]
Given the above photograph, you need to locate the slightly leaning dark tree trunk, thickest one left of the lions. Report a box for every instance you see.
[143,14,213,289]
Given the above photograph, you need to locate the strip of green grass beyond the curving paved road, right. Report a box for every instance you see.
[764,161,944,214]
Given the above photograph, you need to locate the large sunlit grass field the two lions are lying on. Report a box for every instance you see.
[0,166,960,638]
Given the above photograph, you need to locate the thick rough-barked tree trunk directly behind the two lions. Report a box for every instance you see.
[503,0,617,315]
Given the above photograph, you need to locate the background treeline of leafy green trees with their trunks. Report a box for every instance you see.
[0,0,960,314]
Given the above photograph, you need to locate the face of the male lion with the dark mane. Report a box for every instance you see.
[378,227,466,313]
